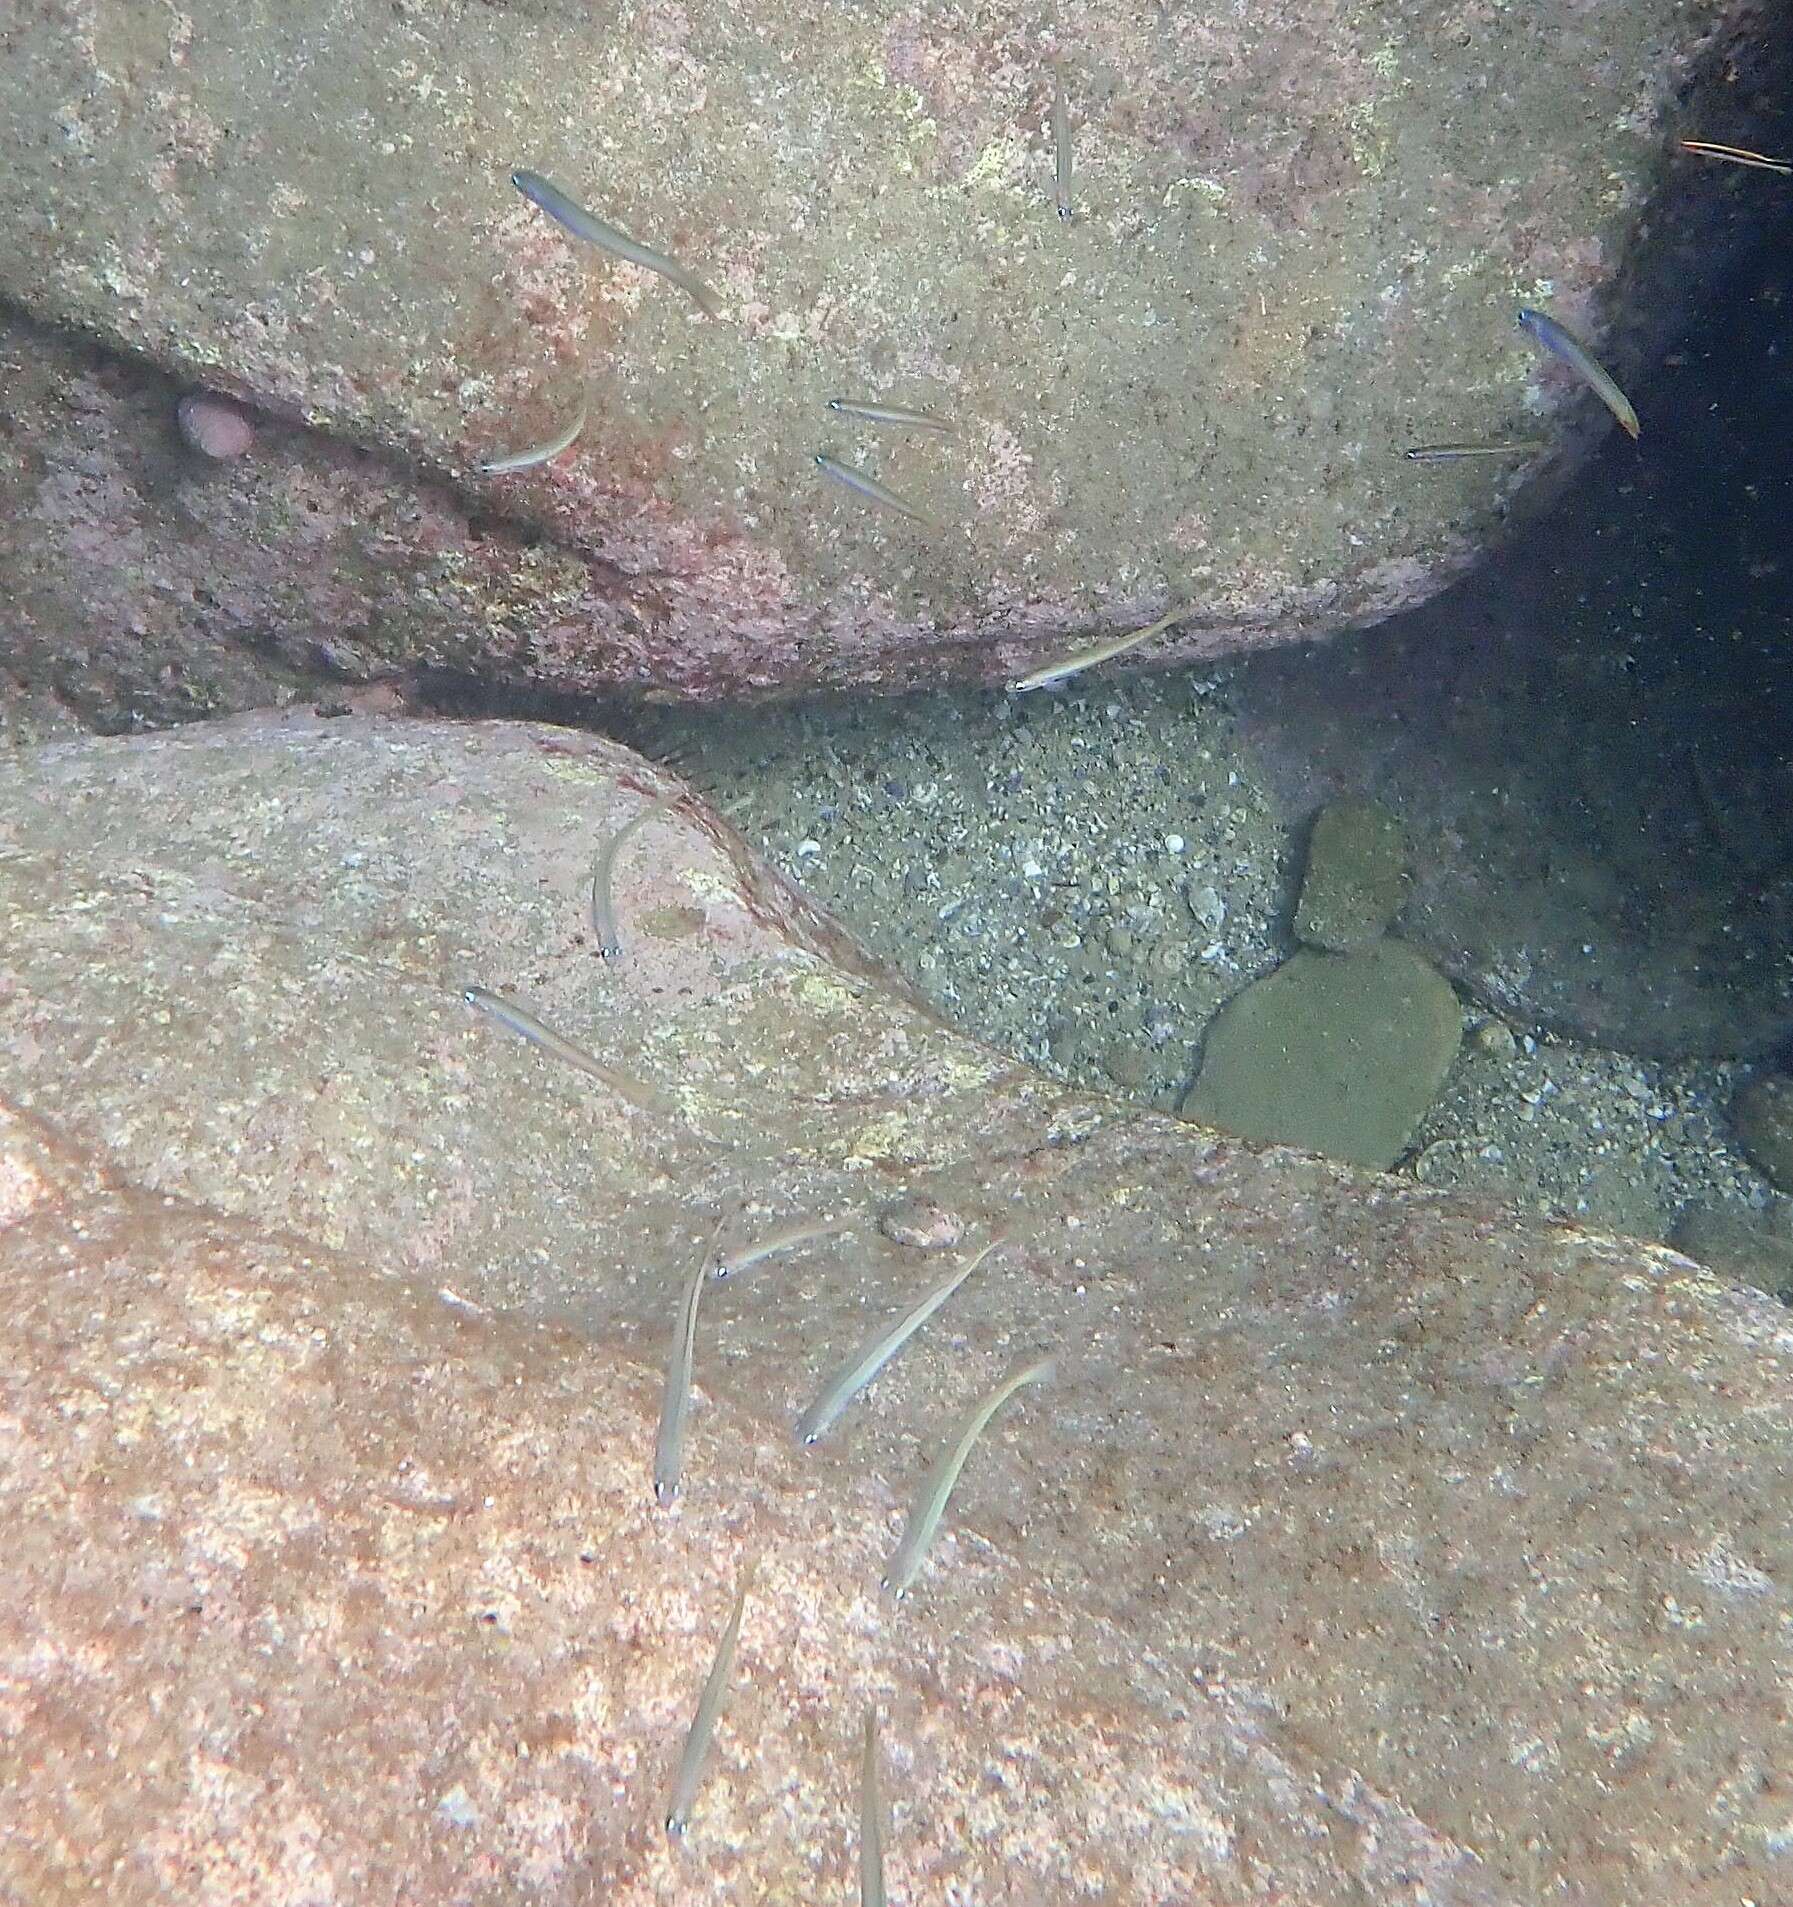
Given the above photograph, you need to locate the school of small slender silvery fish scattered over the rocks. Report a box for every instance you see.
[444,57,1793,1907]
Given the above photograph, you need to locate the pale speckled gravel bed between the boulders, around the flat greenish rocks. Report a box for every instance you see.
[628,645,1770,1238]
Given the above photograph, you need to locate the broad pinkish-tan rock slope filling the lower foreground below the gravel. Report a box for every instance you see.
[0,717,1793,1907]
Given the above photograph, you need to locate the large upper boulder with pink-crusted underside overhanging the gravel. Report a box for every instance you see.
[0,0,1747,696]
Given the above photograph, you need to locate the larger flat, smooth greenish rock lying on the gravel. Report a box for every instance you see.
[1183,940,1463,1169]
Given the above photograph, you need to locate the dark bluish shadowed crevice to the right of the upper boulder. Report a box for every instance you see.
[1242,210,1793,1056]
